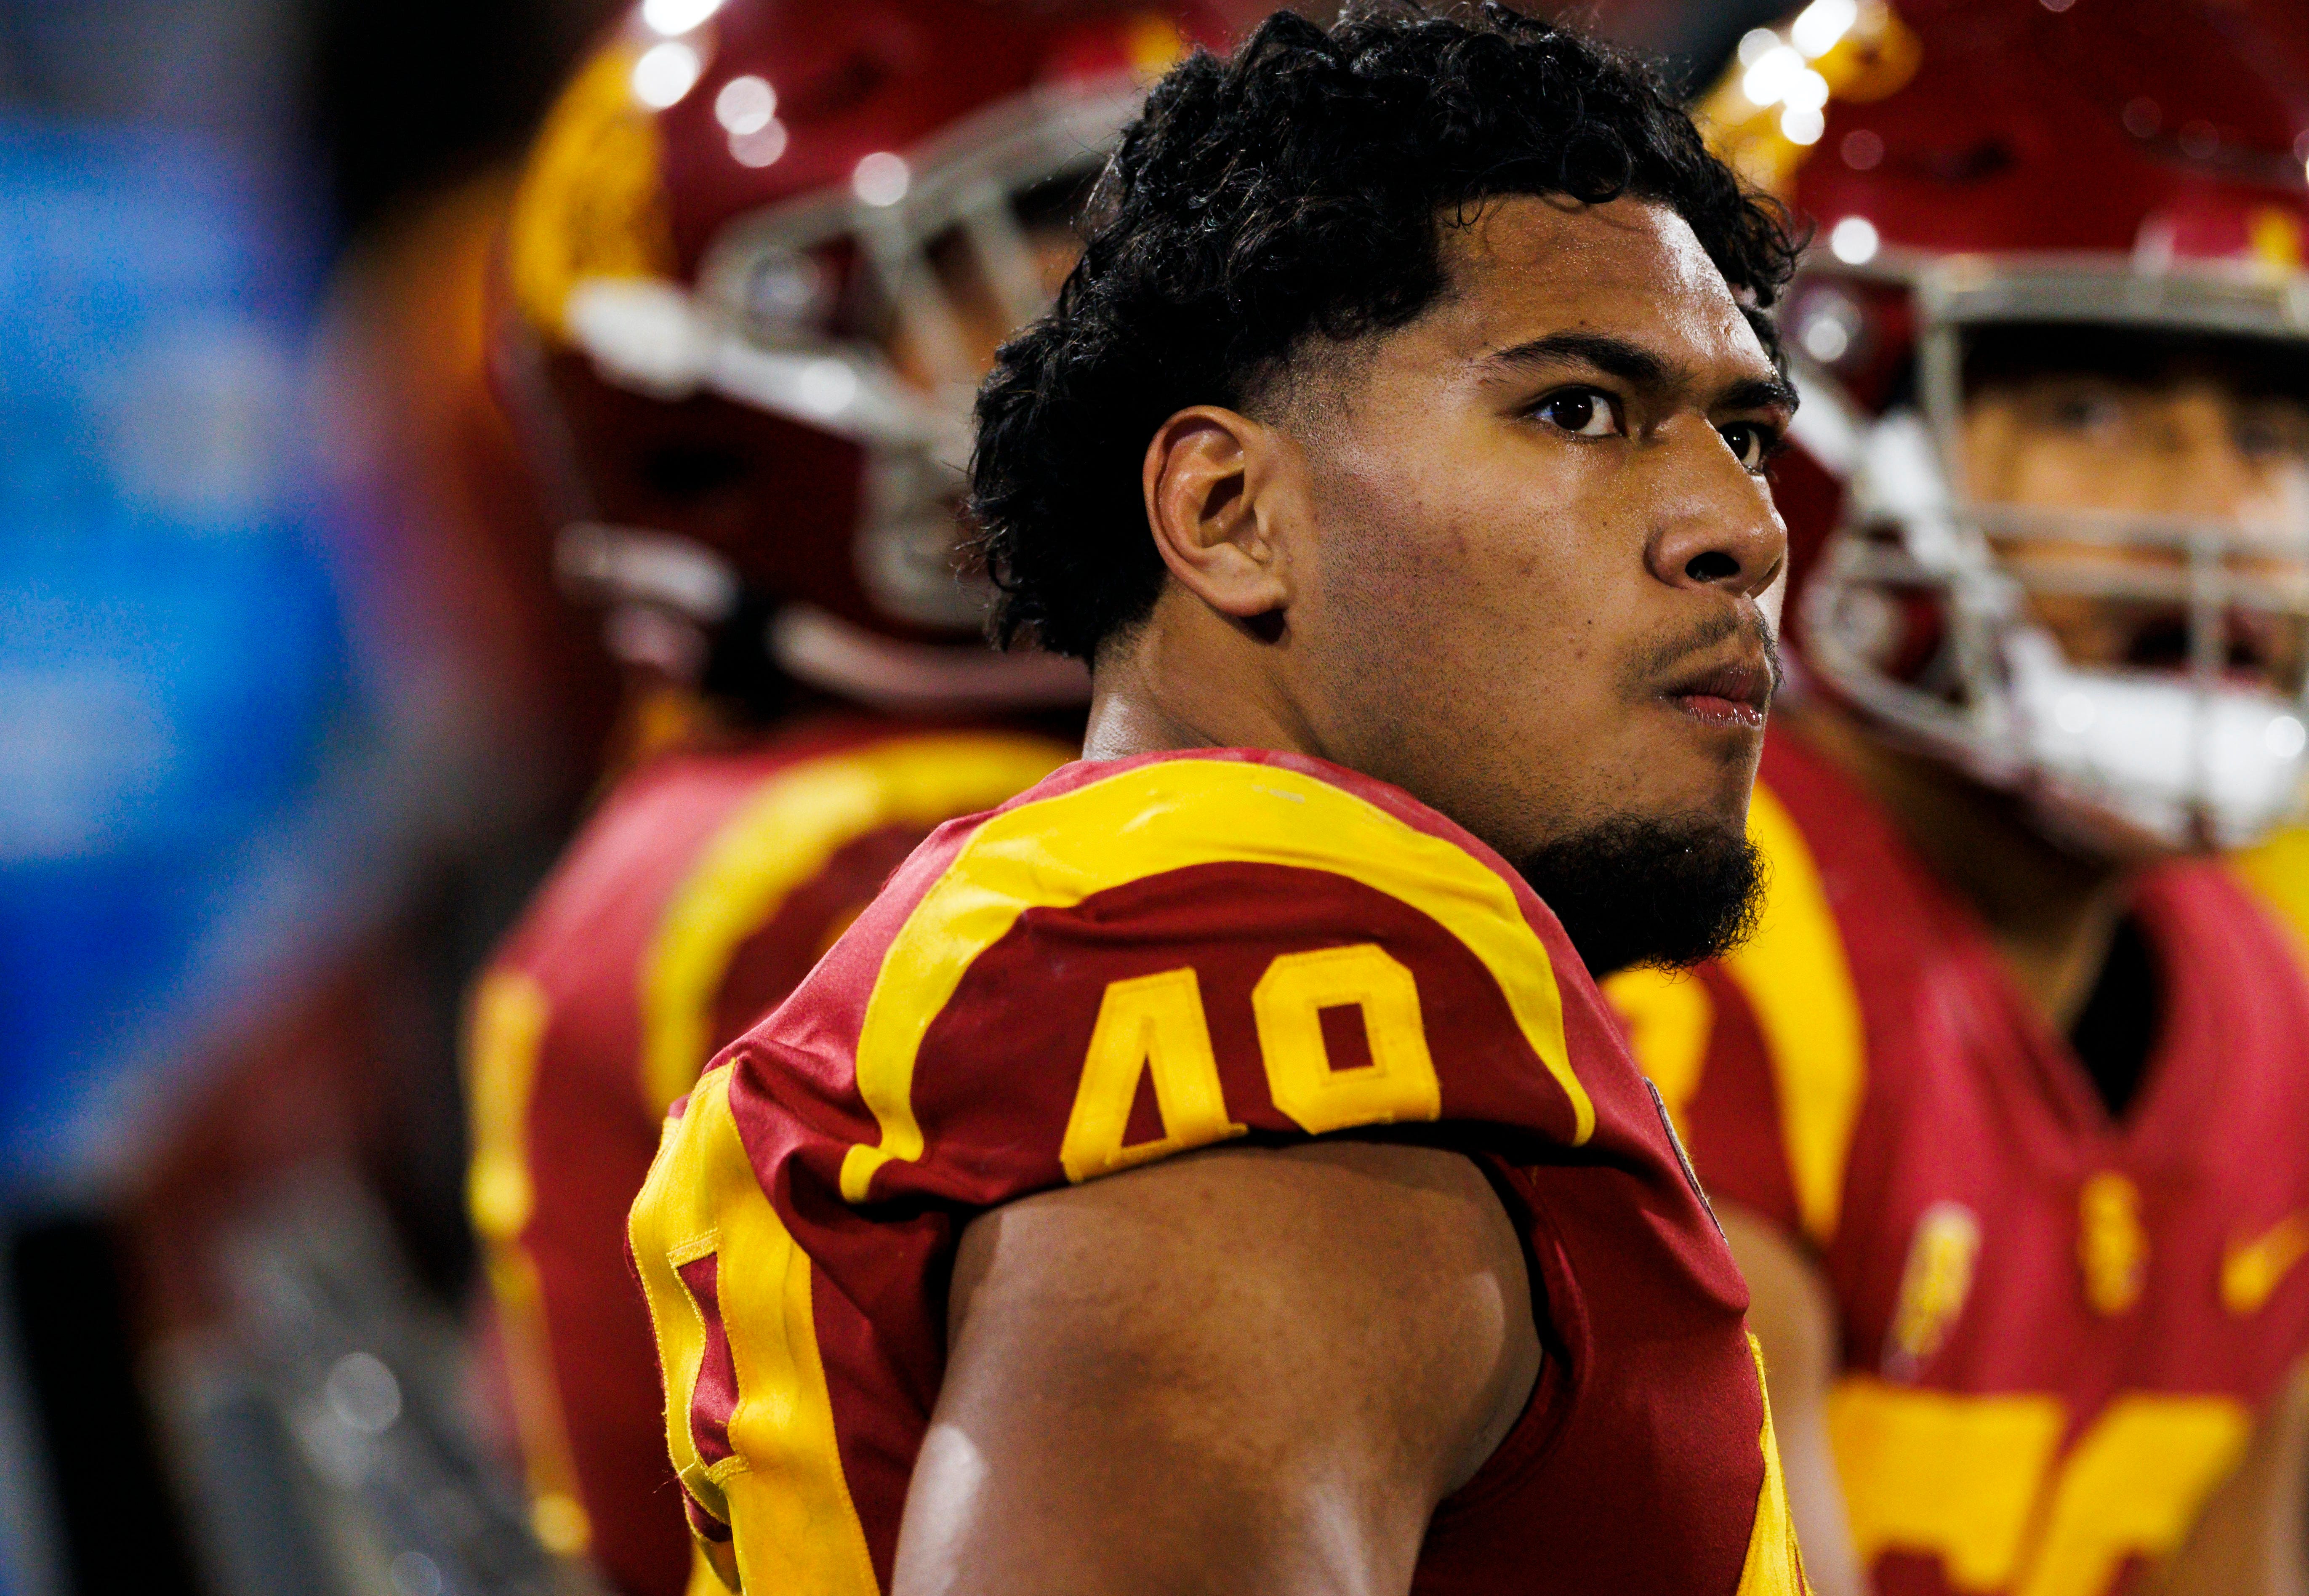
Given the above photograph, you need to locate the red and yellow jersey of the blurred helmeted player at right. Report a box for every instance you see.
[1609,735,2309,1596]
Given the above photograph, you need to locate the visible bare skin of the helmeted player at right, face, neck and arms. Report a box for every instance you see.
[1718,374,2309,1596]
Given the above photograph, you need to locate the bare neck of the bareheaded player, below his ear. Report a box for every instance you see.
[1083,589,1330,760]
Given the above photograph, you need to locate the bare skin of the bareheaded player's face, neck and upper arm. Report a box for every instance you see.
[894,199,1790,1596]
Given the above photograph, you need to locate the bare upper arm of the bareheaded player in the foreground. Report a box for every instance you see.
[894,1141,1540,1596]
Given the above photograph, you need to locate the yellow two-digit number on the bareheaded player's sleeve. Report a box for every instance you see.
[1057,942,1443,1180]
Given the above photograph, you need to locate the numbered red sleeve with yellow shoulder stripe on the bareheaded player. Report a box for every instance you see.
[757,760,1617,1206]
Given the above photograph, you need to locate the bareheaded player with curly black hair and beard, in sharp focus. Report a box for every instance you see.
[630,7,1803,1596]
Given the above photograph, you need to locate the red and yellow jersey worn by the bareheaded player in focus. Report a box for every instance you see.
[633,751,1801,1596]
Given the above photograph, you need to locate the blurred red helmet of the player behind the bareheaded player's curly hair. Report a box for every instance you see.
[496,0,1217,711]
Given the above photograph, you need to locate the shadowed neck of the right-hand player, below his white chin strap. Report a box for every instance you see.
[1787,704,2138,1035]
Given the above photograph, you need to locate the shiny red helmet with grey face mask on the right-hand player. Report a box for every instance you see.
[1699,0,2309,845]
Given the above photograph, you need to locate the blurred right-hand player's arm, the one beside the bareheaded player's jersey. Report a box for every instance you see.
[1718,1203,1868,1596]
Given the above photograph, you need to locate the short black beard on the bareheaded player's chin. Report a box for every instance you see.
[1517,815,1764,982]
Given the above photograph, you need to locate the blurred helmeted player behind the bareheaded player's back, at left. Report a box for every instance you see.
[469,0,1228,1596]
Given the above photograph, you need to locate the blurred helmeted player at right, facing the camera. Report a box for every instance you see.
[1614,0,2309,1596]
